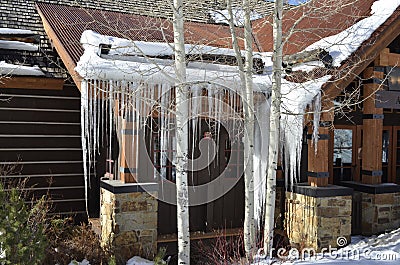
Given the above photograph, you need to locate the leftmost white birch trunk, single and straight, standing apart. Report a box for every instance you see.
[173,0,190,264]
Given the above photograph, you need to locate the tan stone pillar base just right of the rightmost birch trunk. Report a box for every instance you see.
[285,192,352,251]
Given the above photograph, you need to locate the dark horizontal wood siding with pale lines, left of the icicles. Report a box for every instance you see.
[0,85,92,215]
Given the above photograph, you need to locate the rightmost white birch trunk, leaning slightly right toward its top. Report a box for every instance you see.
[264,0,283,255]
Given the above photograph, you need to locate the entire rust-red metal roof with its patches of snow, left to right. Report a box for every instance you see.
[38,0,399,98]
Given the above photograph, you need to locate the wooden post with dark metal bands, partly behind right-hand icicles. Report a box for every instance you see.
[307,101,334,187]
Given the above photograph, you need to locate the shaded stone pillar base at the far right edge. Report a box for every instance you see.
[361,192,400,235]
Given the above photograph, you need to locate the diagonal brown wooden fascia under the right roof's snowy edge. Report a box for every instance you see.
[322,11,400,98]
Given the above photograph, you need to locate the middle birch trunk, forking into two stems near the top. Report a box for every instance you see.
[227,0,256,260]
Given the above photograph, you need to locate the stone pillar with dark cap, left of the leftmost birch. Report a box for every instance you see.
[100,180,158,264]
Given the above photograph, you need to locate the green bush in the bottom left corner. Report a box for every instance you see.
[0,183,48,265]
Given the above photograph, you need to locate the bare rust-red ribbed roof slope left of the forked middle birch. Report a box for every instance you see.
[37,3,238,64]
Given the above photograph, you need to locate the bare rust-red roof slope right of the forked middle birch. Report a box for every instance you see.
[253,0,397,54]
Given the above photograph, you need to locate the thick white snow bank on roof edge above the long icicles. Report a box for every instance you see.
[75,30,271,91]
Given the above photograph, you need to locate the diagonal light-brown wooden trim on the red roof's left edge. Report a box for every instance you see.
[35,4,83,90]
